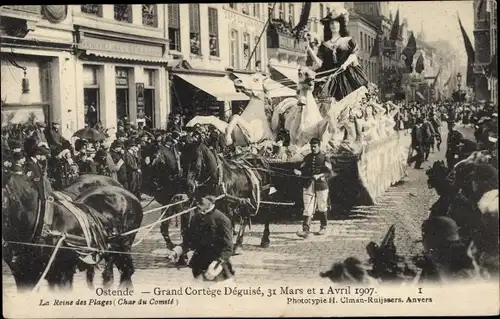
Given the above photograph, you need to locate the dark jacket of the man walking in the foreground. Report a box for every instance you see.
[183,209,233,277]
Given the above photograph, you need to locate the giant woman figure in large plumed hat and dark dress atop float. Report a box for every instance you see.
[308,9,368,101]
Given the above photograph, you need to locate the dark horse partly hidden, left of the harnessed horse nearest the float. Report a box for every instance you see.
[143,145,191,249]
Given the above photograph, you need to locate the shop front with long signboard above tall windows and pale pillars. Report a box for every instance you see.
[76,28,168,132]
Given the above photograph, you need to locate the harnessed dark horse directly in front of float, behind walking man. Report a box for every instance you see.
[181,141,270,251]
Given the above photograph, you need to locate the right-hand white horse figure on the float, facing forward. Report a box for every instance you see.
[271,67,328,148]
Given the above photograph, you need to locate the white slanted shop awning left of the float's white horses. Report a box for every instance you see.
[175,74,249,101]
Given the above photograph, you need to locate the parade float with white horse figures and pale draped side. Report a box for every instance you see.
[187,67,410,207]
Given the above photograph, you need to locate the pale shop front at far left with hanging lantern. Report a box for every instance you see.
[0,5,75,137]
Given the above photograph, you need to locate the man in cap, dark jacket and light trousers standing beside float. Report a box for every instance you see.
[294,138,332,238]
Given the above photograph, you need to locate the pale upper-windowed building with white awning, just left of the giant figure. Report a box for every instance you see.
[166,3,294,120]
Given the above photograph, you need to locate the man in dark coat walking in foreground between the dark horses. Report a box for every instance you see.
[173,195,234,281]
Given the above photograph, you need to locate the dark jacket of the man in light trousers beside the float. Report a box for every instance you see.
[300,153,332,191]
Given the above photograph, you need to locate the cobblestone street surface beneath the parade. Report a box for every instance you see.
[3,129,472,291]
